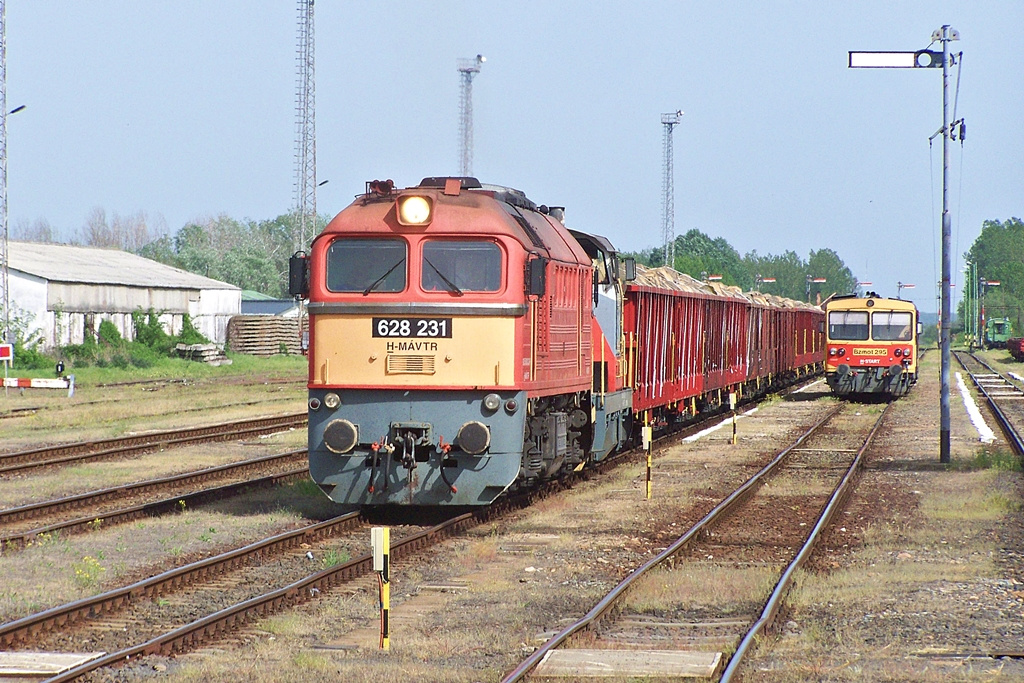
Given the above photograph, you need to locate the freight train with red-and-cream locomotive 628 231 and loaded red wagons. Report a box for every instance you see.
[290,177,823,506]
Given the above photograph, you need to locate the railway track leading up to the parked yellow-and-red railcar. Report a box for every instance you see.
[503,404,889,683]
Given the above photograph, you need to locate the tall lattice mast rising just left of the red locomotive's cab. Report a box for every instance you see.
[294,0,316,251]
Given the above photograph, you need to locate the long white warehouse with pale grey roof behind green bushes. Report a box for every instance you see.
[7,242,242,349]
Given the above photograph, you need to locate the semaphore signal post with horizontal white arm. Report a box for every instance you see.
[849,25,959,463]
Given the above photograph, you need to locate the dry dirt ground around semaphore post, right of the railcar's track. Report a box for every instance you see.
[743,352,1024,683]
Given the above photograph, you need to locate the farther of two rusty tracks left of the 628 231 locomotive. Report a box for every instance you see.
[0,413,307,477]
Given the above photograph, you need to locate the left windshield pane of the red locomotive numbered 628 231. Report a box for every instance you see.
[327,239,408,296]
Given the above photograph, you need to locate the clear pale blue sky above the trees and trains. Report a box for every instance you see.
[7,0,1024,311]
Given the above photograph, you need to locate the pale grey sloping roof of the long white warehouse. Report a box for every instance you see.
[7,242,239,290]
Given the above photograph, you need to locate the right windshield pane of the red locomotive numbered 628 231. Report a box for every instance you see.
[421,240,502,295]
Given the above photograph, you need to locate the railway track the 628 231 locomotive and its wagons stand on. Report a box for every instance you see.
[0,378,823,681]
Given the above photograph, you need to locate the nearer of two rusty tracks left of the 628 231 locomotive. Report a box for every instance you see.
[0,450,308,552]
